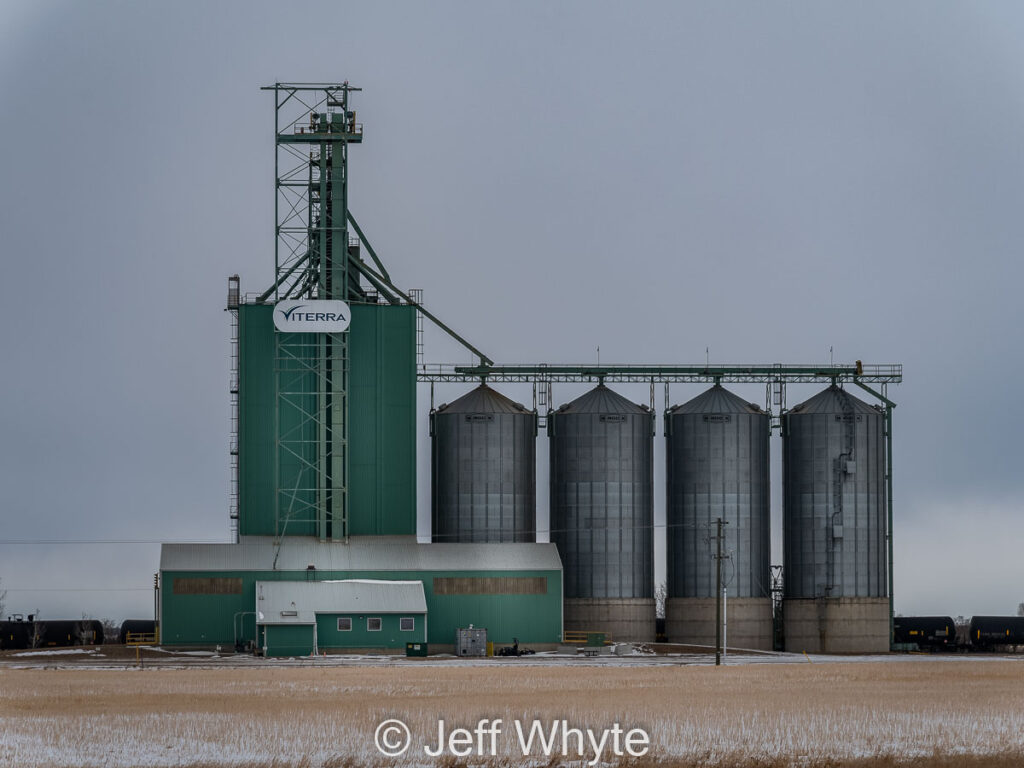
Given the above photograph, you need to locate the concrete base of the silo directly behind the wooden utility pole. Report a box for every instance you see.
[665,597,772,650]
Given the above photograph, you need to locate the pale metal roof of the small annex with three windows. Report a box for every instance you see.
[256,579,427,624]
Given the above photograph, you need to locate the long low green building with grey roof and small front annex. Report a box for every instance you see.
[161,537,562,655]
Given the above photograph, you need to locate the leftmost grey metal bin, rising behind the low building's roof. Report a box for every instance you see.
[430,384,537,543]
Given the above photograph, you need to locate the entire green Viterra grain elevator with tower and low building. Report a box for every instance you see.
[159,83,562,655]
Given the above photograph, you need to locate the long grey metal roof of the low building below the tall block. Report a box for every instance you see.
[160,536,562,571]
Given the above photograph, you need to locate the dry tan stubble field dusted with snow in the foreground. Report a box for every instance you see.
[0,660,1024,768]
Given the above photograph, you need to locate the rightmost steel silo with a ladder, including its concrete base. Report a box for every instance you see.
[782,385,889,652]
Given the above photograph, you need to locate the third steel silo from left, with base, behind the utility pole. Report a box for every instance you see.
[666,384,772,650]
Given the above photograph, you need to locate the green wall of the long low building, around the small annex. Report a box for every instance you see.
[160,570,562,645]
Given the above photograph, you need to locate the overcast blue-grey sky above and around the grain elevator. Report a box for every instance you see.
[0,0,1024,618]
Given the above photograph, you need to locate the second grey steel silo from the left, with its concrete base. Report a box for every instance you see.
[548,384,654,641]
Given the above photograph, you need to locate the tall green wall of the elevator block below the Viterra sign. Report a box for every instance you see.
[239,304,416,536]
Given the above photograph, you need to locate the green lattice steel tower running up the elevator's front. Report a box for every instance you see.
[264,82,365,541]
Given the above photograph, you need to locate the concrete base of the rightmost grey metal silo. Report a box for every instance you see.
[782,597,889,653]
